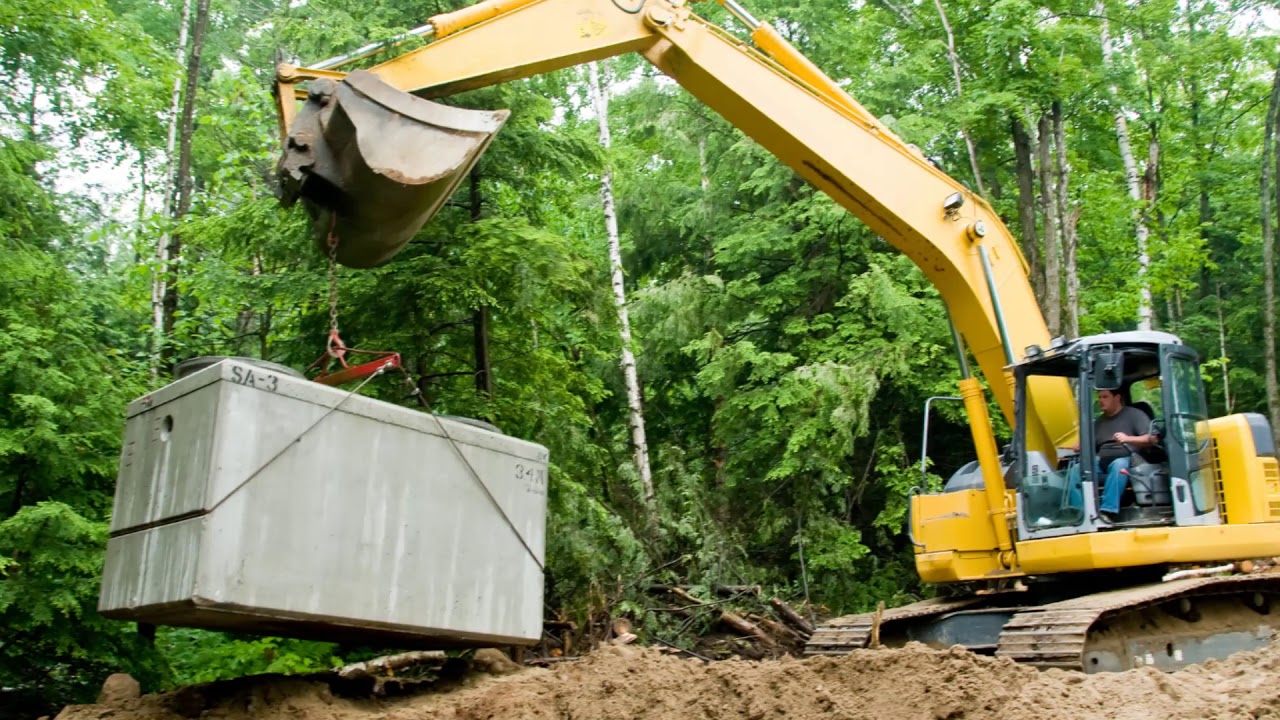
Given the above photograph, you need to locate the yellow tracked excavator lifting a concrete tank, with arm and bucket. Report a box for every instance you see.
[276,0,1280,671]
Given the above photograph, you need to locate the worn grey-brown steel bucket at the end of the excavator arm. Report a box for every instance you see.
[276,70,509,268]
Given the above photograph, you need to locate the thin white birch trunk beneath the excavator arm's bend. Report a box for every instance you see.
[586,61,654,516]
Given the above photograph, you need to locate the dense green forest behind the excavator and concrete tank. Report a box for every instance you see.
[0,0,1280,716]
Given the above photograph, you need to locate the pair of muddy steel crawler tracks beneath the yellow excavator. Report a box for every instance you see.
[805,573,1280,673]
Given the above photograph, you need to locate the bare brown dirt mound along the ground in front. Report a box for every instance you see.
[58,644,1280,720]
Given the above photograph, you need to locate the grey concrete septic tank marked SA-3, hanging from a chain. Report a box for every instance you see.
[99,360,547,647]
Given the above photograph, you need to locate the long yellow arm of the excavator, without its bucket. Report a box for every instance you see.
[278,0,1076,466]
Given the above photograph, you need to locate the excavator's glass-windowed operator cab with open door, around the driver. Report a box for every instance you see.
[1010,332,1221,539]
